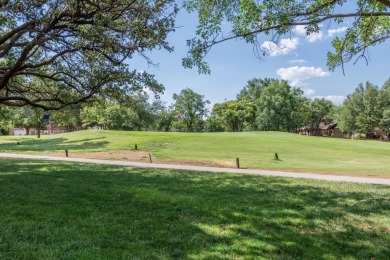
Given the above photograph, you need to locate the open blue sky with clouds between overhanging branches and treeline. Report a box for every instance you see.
[130,10,390,105]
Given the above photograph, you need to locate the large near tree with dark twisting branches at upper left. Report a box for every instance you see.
[0,0,177,110]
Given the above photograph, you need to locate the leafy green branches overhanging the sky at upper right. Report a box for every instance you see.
[183,0,390,72]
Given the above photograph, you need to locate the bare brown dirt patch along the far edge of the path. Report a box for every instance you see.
[47,151,235,168]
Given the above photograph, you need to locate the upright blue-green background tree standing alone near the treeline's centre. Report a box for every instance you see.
[173,88,210,132]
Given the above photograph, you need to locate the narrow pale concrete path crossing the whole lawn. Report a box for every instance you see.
[0,153,390,185]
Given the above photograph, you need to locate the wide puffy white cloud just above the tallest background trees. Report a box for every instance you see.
[276,66,330,81]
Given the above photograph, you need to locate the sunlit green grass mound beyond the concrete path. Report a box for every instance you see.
[0,130,390,176]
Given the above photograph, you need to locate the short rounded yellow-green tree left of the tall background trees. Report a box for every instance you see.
[210,100,256,132]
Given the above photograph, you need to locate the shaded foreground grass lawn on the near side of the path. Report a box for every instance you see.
[0,159,390,259]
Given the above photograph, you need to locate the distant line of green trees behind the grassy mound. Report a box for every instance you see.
[0,78,390,139]
